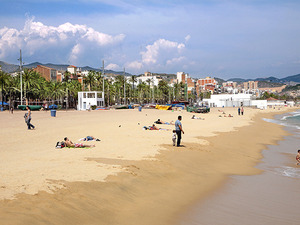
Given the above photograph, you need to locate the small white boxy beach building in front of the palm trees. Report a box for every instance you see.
[77,91,104,110]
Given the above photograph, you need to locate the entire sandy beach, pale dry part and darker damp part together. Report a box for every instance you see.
[0,108,296,224]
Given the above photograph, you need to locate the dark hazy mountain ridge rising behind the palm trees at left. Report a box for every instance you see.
[0,61,132,76]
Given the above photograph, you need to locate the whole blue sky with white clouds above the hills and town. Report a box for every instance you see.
[0,0,300,79]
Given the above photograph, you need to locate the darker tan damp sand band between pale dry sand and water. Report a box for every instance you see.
[0,109,294,224]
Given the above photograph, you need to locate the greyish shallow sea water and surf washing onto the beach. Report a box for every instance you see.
[179,110,300,225]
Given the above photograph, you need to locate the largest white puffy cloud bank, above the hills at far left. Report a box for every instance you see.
[0,18,125,63]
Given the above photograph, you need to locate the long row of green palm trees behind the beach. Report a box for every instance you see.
[0,69,203,108]
